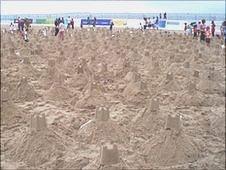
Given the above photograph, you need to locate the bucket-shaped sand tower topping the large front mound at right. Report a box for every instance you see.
[166,115,180,132]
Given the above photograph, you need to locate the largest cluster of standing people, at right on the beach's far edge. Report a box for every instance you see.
[184,19,222,46]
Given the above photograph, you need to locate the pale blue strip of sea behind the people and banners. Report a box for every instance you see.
[1,12,225,32]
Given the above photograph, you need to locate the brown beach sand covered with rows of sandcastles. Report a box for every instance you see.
[1,28,225,170]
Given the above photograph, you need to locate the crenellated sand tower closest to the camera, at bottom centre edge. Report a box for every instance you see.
[100,144,119,165]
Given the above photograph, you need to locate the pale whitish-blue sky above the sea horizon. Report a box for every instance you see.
[1,0,225,15]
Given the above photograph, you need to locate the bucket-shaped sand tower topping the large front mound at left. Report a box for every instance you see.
[31,114,47,132]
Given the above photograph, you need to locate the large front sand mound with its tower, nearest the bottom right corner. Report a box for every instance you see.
[144,117,199,166]
